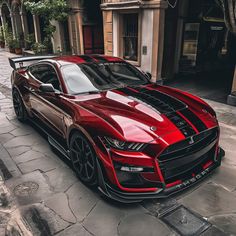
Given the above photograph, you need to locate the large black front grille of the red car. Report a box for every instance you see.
[158,128,218,183]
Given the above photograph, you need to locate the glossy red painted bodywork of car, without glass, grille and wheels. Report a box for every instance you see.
[12,56,222,201]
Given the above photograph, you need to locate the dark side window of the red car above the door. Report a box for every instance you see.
[29,64,62,91]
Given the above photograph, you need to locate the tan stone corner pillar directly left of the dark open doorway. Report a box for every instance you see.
[151,0,167,82]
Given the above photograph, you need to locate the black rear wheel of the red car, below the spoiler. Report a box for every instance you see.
[12,89,28,122]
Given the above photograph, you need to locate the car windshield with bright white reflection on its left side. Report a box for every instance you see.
[62,62,148,94]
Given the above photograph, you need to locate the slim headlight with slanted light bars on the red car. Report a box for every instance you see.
[103,137,145,151]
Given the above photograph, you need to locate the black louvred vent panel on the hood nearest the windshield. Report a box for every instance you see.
[119,87,187,114]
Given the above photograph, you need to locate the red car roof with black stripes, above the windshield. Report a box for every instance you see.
[49,55,124,65]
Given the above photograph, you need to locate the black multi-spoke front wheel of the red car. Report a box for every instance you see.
[70,132,98,186]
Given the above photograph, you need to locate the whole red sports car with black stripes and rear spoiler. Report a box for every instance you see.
[9,55,222,202]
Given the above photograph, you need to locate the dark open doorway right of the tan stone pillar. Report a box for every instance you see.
[163,0,236,103]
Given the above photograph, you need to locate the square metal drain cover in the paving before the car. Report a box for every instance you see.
[161,206,211,236]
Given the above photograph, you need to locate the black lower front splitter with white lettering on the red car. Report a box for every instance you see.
[98,148,224,203]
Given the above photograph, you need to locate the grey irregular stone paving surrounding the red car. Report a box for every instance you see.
[0,48,236,236]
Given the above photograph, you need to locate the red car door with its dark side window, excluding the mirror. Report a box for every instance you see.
[29,63,65,137]
